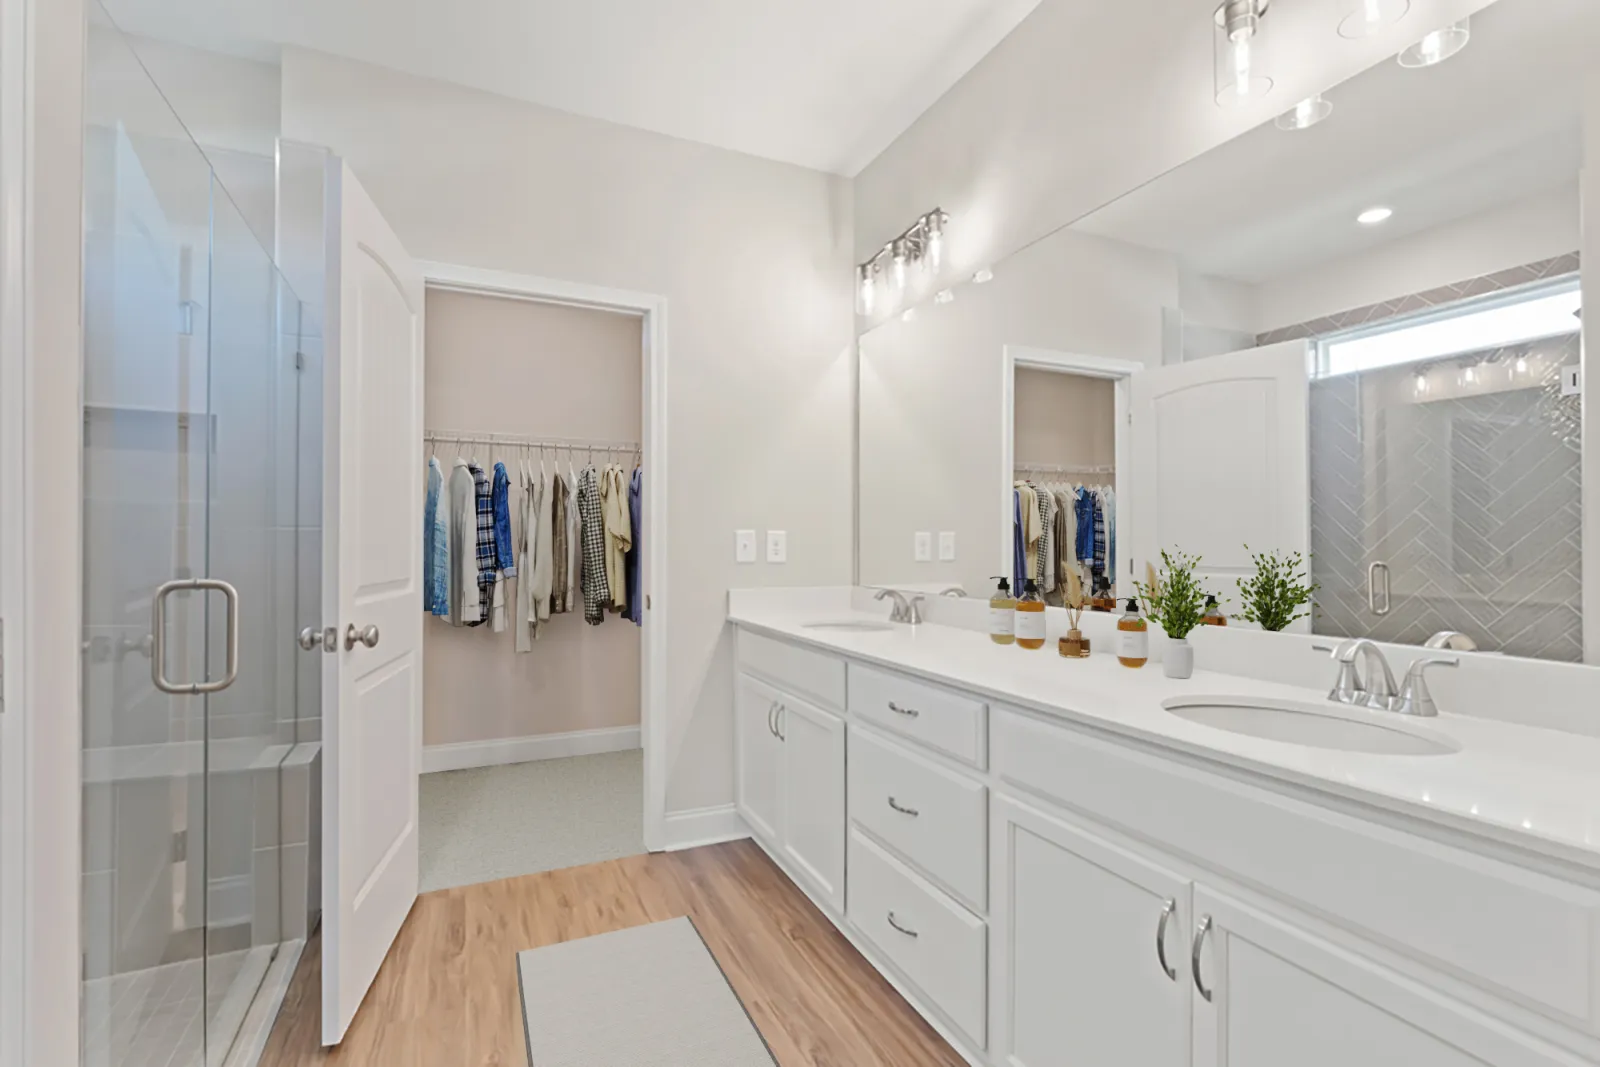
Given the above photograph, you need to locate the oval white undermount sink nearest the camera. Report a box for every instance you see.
[1162,696,1461,755]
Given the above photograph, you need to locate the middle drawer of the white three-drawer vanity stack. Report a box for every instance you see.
[850,728,989,910]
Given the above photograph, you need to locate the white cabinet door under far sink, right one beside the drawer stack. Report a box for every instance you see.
[778,694,845,910]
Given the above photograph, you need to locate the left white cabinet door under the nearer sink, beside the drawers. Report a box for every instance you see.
[990,797,1196,1067]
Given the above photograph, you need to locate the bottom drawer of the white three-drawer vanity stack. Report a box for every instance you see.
[845,830,989,1048]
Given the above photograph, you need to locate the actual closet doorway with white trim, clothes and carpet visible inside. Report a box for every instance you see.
[419,264,666,893]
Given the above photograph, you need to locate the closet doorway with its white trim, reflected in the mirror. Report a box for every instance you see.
[997,346,1142,606]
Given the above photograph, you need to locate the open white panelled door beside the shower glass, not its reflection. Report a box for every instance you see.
[322,163,422,1045]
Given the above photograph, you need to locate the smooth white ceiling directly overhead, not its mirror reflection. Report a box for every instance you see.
[104,0,1040,174]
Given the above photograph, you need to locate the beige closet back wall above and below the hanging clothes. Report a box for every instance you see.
[422,290,643,744]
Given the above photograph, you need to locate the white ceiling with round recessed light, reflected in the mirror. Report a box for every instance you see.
[1075,0,1594,283]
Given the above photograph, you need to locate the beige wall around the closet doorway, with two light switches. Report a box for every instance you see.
[283,48,854,813]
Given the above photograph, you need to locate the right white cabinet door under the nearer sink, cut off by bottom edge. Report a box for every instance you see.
[1181,886,1578,1067]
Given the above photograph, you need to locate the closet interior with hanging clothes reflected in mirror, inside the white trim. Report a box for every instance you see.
[1011,366,1126,605]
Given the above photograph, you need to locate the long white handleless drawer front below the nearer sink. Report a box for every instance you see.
[994,709,1600,1033]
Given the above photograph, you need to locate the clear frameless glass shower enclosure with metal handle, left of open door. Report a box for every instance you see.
[82,8,302,1067]
